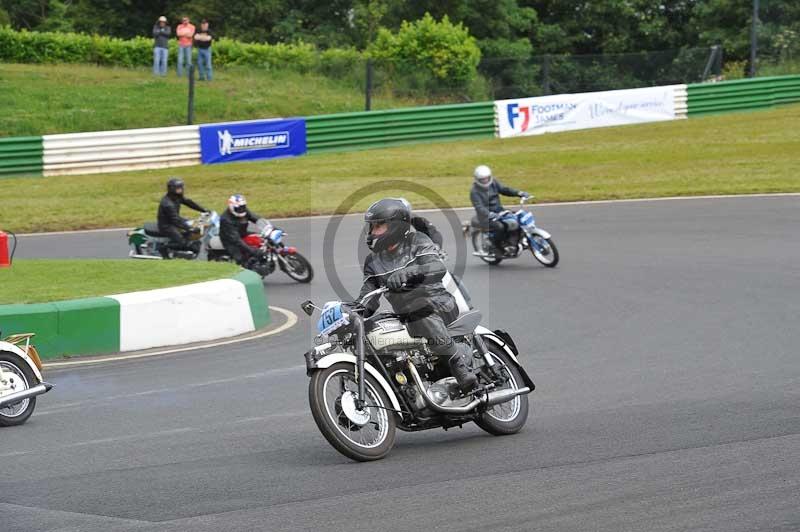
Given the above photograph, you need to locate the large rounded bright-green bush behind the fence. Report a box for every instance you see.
[370,13,481,87]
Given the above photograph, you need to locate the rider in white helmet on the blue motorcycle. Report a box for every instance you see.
[469,165,530,255]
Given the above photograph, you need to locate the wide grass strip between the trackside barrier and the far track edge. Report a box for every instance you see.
[0,105,800,232]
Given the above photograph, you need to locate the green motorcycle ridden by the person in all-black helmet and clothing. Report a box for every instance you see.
[128,212,219,260]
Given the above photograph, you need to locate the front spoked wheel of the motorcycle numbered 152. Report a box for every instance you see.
[308,362,397,462]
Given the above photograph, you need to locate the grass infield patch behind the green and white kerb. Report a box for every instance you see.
[0,259,239,305]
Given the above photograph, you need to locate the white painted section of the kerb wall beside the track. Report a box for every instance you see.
[109,279,255,351]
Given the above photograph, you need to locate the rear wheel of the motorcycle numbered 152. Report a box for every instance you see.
[475,345,528,436]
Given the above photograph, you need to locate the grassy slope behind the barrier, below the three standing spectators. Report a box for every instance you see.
[0,64,416,137]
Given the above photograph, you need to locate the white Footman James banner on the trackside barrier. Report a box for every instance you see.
[494,86,675,138]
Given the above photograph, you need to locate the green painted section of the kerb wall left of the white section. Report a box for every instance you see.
[0,297,119,359]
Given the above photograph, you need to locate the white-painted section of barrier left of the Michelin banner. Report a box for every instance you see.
[43,126,200,176]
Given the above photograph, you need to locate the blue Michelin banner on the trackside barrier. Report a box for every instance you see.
[200,118,306,164]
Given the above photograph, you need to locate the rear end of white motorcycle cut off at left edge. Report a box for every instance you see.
[0,333,53,427]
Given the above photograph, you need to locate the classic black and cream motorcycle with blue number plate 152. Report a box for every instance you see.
[301,288,534,461]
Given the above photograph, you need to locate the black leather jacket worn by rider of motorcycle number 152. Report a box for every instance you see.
[358,232,455,316]
